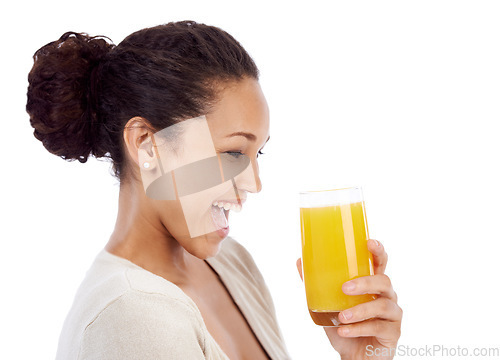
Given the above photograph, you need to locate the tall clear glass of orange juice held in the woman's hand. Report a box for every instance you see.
[300,187,376,326]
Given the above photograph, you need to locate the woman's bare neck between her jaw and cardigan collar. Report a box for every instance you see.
[105,183,199,283]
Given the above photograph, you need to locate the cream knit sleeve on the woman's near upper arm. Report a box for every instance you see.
[78,290,206,360]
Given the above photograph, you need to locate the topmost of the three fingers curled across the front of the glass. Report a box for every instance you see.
[342,274,398,303]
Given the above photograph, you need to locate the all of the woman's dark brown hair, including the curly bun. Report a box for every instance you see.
[26,21,259,181]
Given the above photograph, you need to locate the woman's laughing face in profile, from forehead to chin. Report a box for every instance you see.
[139,78,269,259]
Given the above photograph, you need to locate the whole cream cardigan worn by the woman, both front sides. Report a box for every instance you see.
[56,238,290,360]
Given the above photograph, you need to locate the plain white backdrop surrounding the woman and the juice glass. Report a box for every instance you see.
[0,0,500,359]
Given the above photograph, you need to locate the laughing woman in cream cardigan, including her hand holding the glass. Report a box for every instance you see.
[27,21,402,359]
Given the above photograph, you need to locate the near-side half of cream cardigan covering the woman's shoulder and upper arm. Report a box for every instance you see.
[58,251,221,359]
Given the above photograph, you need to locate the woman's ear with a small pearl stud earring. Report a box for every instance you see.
[123,116,156,170]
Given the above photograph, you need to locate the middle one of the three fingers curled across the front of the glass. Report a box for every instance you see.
[339,298,403,324]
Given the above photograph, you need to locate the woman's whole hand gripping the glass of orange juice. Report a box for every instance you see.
[297,240,403,360]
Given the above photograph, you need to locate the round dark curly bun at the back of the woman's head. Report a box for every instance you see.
[26,32,114,162]
